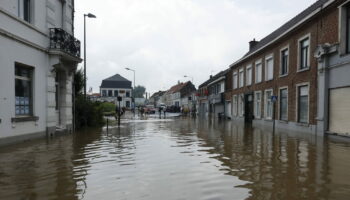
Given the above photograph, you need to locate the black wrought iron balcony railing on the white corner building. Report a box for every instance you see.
[50,28,80,58]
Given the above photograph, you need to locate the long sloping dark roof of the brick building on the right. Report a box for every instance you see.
[230,0,333,67]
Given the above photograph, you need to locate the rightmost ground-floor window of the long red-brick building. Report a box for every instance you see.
[297,85,309,123]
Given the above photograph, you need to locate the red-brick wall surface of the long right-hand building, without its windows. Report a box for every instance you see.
[225,1,344,125]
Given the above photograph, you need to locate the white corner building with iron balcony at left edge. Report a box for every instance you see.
[0,0,82,143]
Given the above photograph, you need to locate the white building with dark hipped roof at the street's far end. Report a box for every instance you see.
[100,74,132,108]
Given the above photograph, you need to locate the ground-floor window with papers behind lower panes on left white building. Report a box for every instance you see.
[15,64,33,116]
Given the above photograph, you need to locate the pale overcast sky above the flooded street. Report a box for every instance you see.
[75,0,315,93]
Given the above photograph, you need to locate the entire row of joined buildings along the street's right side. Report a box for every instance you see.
[197,0,350,136]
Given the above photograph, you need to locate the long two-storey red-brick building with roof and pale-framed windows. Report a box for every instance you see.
[225,0,350,133]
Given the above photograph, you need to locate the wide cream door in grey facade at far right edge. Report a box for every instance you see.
[329,87,350,135]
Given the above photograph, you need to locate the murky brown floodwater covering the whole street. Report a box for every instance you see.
[0,119,350,200]
